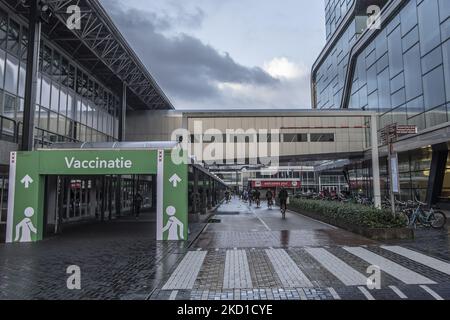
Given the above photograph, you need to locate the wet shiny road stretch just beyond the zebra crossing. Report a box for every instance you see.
[195,199,375,249]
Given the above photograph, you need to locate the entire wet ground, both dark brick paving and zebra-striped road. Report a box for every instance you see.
[0,199,450,300]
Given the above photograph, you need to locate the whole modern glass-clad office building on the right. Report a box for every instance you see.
[311,0,450,204]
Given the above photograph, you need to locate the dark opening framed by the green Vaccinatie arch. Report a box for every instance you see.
[44,175,156,236]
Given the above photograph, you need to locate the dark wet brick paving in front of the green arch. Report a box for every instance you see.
[0,212,204,300]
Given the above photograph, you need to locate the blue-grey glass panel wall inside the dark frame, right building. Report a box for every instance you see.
[348,0,450,131]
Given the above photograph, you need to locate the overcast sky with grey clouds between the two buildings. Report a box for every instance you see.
[101,0,325,109]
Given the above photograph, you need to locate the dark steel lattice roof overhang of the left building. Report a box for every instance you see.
[7,0,174,110]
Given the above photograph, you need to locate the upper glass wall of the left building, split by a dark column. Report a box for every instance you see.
[0,6,120,142]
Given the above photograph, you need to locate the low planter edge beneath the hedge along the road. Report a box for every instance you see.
[289,207,414,241]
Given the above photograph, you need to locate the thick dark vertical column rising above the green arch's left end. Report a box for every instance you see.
[21,0,41,151]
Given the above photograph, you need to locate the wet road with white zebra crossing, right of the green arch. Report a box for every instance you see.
[150,199,450,300]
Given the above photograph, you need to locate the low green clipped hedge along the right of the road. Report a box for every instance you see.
[289,199,406,229]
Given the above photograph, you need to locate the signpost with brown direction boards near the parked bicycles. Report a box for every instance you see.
[381,123,418,215]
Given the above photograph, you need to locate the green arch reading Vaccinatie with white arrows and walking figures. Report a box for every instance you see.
[6,149,188,243]
